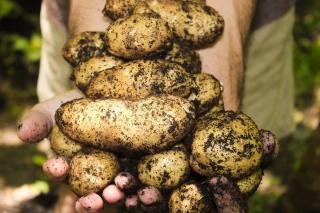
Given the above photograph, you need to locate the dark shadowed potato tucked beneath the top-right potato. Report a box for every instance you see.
[165,42,201,74]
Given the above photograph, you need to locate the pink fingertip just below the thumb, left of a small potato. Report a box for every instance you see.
[42,156,70,181]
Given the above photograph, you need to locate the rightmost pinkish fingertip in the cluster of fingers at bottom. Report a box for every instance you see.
[138,186,162,206]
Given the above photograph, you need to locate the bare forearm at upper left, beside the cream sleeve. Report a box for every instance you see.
[68,0,111,35]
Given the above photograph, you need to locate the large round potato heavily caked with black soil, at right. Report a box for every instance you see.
[192,111,263,178]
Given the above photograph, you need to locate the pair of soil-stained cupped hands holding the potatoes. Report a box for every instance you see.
[17,90,274,213]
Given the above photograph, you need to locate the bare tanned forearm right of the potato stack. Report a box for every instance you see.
[199,0,256,110]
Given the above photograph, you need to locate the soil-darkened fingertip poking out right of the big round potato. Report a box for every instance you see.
[260,130,279,168]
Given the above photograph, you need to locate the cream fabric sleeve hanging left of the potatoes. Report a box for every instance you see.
[37,0,72,101]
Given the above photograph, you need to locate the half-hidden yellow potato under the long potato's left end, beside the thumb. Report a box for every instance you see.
[49,125,83,158]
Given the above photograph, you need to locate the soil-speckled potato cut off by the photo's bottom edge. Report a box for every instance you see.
[169,183,215,213]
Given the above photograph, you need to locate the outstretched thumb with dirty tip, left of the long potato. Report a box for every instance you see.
[17,90,83,143]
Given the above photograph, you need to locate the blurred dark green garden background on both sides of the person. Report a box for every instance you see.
[0,0,320,212]
